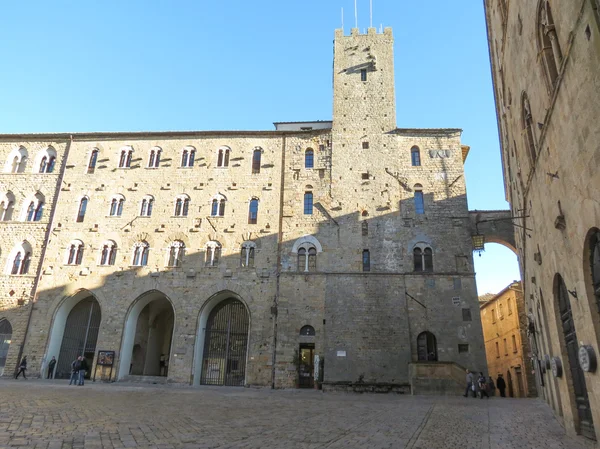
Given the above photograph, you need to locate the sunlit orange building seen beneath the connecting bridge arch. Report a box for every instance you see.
[479,282,537,398]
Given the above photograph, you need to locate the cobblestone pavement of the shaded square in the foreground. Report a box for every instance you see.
[0,380,589,449]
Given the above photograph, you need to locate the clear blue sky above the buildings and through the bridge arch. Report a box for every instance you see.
[0,0,519,294]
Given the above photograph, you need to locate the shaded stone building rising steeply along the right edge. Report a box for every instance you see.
[485,0,600,440]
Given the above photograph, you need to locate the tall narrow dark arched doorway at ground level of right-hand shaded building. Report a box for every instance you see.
[554,274,596,440]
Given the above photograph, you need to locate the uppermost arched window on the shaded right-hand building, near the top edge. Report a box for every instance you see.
[538,0,562,88]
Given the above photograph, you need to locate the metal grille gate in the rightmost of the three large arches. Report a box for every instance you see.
[200,299,249,387]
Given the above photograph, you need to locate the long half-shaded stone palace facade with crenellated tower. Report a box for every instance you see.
[0,29,485,391]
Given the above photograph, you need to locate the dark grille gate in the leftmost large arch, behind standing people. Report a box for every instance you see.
[56,296,101,379]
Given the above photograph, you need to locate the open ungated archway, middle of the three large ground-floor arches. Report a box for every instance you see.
[119,291,175,379]
